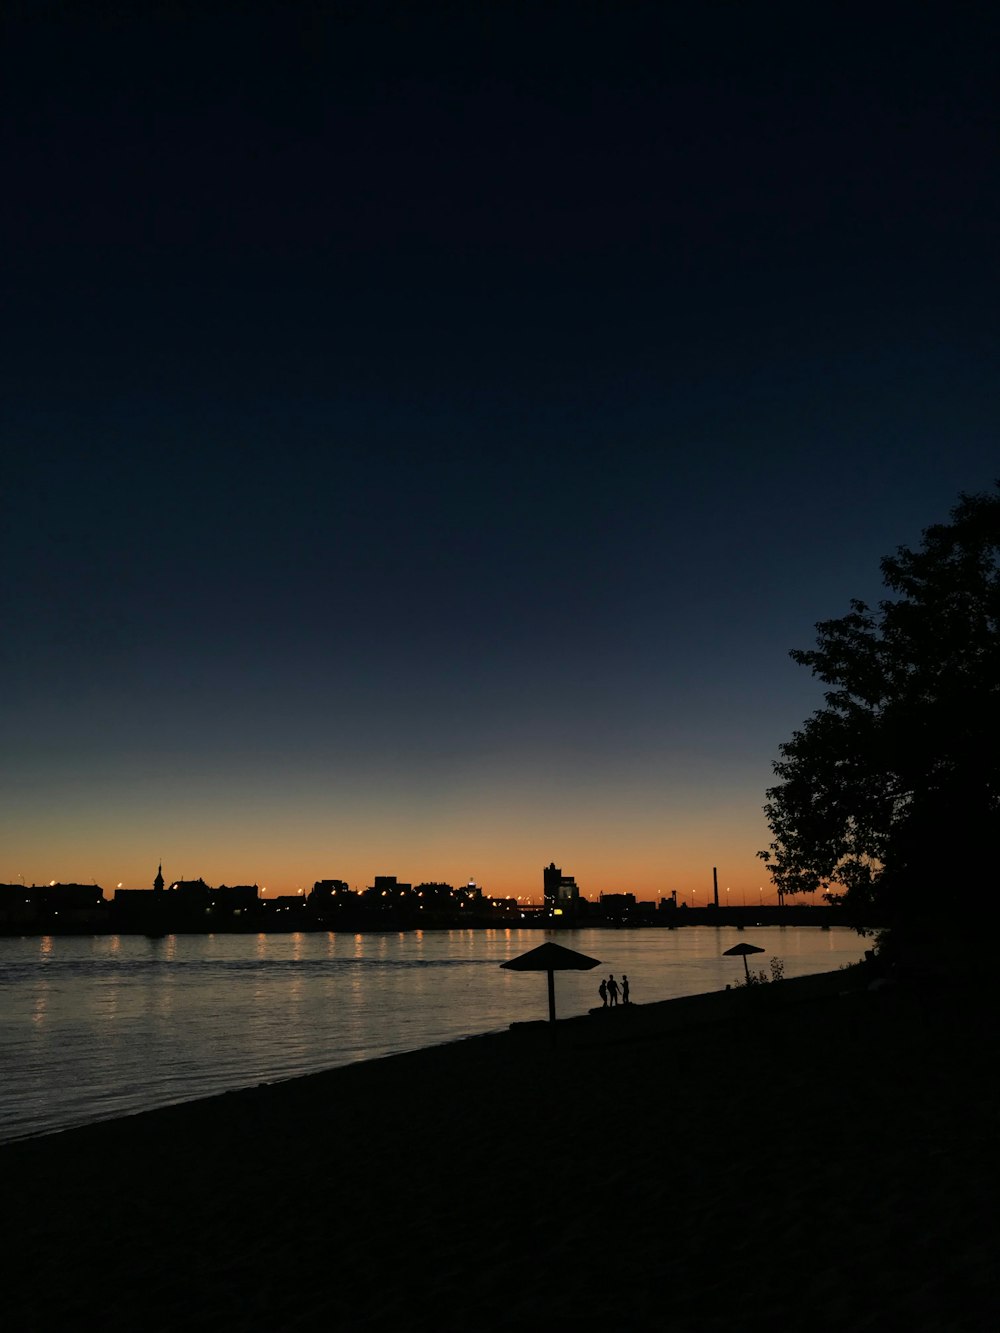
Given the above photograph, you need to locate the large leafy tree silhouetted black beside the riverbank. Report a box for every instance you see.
[759,484,1000,924]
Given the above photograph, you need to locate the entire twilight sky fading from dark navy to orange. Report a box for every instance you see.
[0,3,1000,904]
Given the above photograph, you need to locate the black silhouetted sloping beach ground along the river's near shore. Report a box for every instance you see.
[0,969,1000,1333]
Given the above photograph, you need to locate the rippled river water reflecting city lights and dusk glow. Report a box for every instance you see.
[0,926,864,1140]
